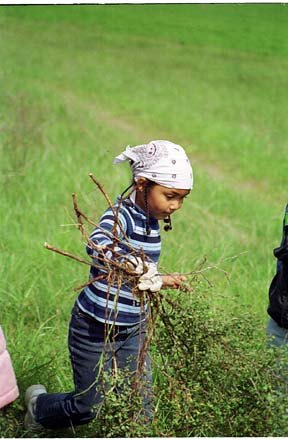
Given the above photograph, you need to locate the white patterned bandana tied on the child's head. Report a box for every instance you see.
[114,140,193,190]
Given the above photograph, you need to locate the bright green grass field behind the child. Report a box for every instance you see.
[0,4,288,437]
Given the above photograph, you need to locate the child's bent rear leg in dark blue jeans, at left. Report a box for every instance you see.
[35,307,111,429]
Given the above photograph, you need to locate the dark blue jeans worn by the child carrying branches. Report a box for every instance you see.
[35,305,152,429]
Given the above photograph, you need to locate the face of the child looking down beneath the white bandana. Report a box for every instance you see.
[143,184,190,220]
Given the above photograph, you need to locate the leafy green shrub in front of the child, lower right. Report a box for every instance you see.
[153,293,288,436]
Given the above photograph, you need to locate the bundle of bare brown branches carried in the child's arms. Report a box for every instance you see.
[45,174,223,426]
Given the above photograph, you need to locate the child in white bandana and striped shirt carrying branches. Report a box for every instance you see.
[25,140,193,430]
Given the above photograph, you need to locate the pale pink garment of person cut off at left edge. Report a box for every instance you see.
[0,326,19,409]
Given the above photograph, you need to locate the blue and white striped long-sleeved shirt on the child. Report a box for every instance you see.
[77,197,161,326]
